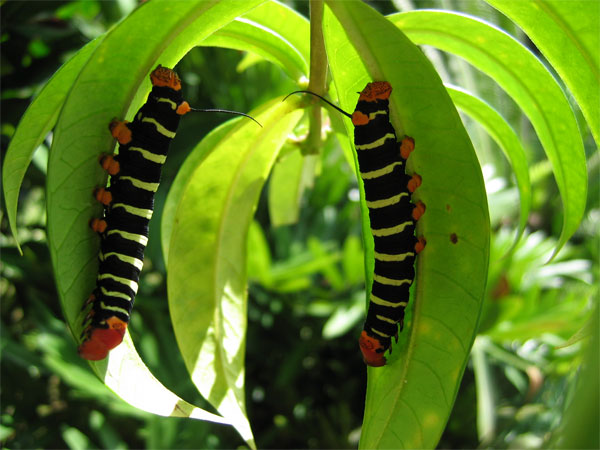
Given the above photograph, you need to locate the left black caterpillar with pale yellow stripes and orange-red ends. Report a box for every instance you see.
[78,65,260,361]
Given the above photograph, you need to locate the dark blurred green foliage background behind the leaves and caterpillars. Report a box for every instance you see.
[0,0,600,449]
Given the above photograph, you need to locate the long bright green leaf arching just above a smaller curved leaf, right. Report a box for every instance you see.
[388,11,587,255]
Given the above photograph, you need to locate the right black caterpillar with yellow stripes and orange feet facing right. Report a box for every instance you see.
[290,81,426,367]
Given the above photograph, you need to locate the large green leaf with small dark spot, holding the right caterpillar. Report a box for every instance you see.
[324,1,490,448]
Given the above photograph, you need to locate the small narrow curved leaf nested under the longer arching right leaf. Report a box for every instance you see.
[446,86,531,242]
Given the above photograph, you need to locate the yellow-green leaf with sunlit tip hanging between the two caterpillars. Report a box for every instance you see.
[167,98,302,447]
